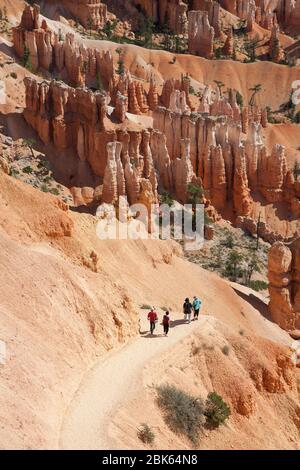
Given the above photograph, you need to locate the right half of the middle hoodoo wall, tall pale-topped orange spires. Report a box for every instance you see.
[153,81,299,222]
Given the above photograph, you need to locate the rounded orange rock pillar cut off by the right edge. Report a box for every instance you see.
[268,239,300,330]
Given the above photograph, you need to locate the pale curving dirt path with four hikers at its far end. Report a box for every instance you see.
[59,311,214,450]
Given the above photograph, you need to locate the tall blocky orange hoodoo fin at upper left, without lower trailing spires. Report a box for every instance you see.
[13,5,114,90]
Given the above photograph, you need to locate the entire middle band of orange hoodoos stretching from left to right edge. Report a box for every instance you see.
[24,73,300,223]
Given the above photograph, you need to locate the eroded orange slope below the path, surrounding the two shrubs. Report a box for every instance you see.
[106,317,300,449]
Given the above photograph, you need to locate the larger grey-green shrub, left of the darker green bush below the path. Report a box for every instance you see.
[157,385,204,445]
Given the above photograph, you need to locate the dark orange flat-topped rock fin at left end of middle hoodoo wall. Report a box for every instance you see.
[24,77,112,176]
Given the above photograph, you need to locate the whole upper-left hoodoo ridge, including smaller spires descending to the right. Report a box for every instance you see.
[13,5,158,115]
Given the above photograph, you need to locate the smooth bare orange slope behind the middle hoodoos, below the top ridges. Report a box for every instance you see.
[84,40,300,109]
